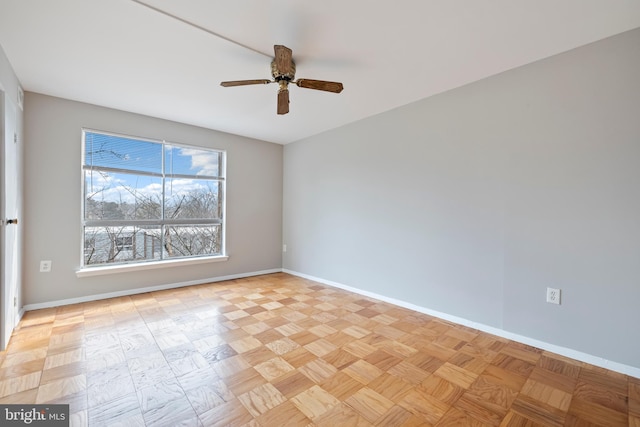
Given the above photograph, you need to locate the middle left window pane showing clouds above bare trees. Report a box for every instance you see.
[84,170,162,220]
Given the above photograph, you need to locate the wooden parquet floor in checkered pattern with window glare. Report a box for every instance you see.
[0,273,640,427]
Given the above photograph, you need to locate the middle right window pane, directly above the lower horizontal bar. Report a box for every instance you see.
[164,178,221,219]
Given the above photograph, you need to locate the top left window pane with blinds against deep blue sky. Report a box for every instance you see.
[85,132,162,173]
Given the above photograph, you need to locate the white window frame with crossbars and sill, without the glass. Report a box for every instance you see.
[76,128,228,277]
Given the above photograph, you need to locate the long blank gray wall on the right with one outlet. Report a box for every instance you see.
[283,30,640,367]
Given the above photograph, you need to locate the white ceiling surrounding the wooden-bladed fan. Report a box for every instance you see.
[0,0,640,144]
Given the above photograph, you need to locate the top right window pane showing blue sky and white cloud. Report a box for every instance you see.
[165,145,220,176]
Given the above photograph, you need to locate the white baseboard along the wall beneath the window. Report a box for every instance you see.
[21,268,282,317]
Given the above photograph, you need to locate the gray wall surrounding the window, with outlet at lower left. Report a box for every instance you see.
[23,93,283,304]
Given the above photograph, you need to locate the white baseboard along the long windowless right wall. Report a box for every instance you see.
[282,268,640,378]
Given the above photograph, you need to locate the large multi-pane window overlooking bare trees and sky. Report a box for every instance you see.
[82,130,225,267]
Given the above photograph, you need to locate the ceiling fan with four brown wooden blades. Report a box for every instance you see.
[220,45,343,114]
